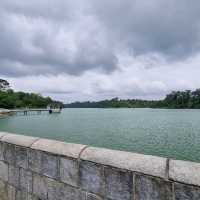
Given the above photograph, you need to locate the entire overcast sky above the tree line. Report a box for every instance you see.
[0,0,200,102]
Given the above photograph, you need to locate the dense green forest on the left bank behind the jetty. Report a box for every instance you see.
[0,79,62,109]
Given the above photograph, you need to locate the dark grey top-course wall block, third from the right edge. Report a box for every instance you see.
[105,167,133,200]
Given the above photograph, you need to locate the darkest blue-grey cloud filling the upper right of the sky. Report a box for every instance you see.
[91,0,200,59]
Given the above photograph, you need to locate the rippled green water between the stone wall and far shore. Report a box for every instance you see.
[0,109,200,161]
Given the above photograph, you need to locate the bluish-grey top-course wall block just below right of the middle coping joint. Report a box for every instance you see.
[80,161,104,194]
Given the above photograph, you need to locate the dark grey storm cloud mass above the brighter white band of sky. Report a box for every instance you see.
[0,0,200,76]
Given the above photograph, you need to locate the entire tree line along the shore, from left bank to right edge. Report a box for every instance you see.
[0,79,200,109]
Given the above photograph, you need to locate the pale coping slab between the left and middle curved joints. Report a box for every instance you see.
[31,139,86,158]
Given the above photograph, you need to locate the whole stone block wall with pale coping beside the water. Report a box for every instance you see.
[0,132,200,200]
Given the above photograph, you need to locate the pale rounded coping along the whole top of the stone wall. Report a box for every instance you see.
[0,132,200,186]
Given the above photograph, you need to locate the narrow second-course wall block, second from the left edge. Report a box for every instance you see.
[8,165,19,188]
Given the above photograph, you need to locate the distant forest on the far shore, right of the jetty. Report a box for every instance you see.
[65,89,200,108]
